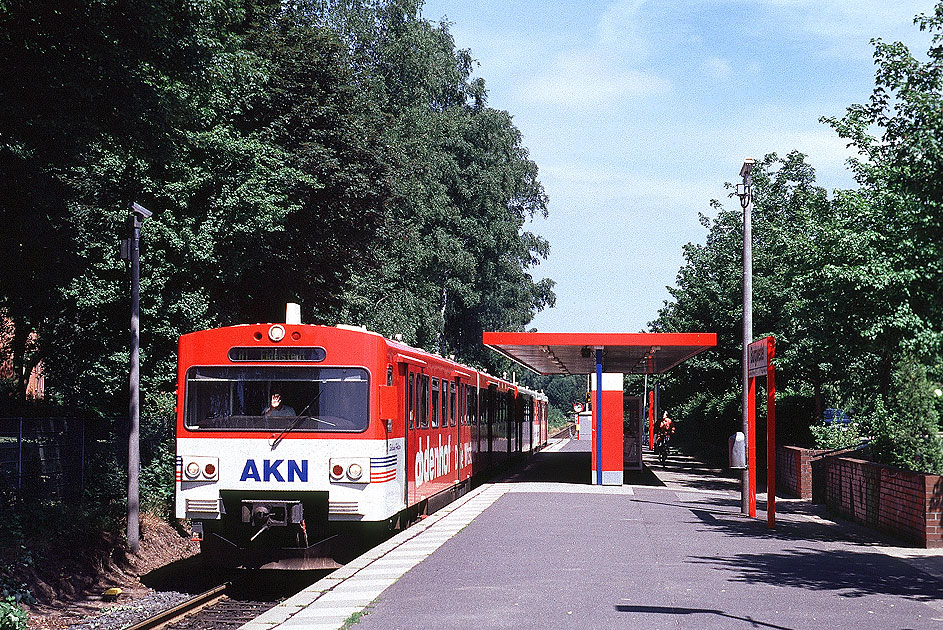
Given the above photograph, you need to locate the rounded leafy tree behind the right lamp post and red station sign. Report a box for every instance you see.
[652,152,908,454]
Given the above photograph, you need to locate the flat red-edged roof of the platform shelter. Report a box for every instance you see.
[482,332,717,374]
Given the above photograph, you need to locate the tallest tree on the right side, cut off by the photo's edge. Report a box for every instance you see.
[823,3,943,368]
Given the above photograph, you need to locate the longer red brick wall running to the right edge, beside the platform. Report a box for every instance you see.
[815,457,943,548]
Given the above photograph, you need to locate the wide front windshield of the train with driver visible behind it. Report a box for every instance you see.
[184,366,370,432]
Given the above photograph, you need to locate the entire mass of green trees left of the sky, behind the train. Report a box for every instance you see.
[0,0,554,524]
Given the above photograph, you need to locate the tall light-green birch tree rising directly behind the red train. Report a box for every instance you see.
[328,2,554,364]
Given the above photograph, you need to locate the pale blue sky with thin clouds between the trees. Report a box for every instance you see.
[423,0,934,332]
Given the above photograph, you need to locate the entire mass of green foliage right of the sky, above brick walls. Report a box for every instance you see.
[653,3,943,470]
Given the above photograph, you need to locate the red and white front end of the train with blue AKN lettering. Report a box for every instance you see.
[176,324,405,569]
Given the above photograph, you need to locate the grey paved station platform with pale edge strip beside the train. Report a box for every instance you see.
[242,440,943,630]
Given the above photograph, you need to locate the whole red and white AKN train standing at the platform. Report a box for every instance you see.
[176,324,547,568]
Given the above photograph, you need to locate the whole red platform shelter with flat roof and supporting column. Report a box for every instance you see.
[482,332,717,485]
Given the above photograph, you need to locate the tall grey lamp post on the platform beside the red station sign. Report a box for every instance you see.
[737,158,756,514]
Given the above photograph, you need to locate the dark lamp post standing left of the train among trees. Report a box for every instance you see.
[128,203,152,553]
